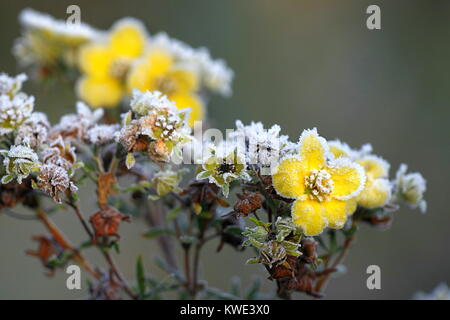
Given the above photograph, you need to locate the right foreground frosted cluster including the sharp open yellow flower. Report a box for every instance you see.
[197,126,426,236]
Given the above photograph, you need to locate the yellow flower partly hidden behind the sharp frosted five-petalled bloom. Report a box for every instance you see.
[328,141,391,214]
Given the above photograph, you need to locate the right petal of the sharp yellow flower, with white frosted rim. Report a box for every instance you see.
[327,158,366,200]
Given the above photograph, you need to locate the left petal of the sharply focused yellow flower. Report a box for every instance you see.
[272,157,306,198]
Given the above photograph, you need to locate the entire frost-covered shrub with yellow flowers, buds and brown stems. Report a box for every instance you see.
[0,9,426,299]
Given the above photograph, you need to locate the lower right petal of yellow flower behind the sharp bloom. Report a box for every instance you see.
[356,177,391,209]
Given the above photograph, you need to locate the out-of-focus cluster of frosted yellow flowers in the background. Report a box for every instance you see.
[13,9,233,125]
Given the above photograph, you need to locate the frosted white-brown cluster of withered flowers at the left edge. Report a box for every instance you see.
[0,74,108,202]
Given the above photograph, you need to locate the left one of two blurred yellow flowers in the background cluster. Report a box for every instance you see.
[77,18,146,108]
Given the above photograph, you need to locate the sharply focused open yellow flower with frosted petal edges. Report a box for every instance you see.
[272,129,365,236]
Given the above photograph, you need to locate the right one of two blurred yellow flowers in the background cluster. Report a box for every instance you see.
[127,50,204,127]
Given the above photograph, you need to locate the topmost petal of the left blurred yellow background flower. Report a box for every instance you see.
[109,18,146,58]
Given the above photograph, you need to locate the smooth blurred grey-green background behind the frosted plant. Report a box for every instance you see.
[0,0,450,299]
